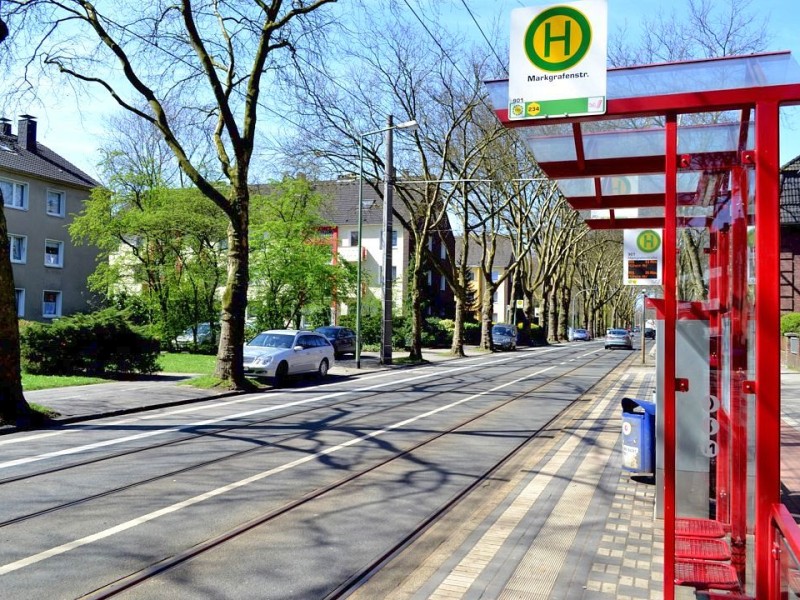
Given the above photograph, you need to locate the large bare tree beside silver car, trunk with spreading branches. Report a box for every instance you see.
[0,0,335,387]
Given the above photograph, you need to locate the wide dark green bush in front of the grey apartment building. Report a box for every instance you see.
[20,309,160,377]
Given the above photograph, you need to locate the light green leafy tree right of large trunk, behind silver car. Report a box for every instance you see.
[250,178,355,328]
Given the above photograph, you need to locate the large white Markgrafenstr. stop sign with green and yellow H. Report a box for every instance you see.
[508,0,608,119]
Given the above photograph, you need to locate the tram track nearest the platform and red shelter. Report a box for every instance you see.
[69,346,624,600]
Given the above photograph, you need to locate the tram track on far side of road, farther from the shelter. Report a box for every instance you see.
[0,344,599,529]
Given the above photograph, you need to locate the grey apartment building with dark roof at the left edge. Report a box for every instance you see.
[0,115,99,321]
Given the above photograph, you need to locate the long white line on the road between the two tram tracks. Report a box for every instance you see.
[0,367,555,575]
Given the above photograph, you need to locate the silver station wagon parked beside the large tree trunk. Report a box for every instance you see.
[244,329,334,386]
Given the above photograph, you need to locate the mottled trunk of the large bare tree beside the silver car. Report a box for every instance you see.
[214,191,250,389]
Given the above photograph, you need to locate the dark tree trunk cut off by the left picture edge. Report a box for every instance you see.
[0,202,30,426]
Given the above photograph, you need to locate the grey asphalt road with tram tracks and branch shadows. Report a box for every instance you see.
[0,341,630,600]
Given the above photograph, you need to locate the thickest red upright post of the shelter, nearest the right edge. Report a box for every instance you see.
[755,101,781,598]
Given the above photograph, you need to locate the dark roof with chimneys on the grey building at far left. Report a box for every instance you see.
[0,135,100,189]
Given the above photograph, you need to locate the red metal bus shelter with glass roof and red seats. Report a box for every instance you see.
[487,52,800,599]
